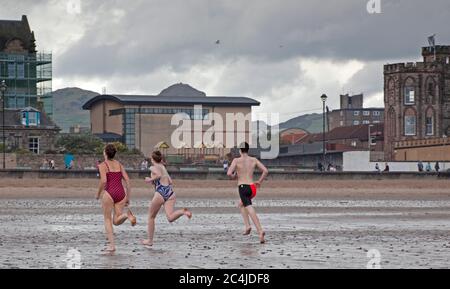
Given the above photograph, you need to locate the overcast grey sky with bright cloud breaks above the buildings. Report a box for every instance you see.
[0,0,450,120]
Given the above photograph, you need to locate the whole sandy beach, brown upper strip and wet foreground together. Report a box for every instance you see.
[0,179,450,269]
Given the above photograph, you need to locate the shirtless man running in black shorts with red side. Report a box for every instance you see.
[227,143,269,244]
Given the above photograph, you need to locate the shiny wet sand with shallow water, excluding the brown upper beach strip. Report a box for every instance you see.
[0,198,450,268]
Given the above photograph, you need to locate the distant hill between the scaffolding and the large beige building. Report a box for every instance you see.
[53,87,98,132]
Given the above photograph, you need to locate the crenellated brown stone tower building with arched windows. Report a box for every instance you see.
[384,46,450,161]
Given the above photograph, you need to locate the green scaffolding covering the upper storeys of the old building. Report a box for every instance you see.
[0,52,53,118]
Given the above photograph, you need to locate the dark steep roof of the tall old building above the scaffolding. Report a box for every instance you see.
[0,15,36,52]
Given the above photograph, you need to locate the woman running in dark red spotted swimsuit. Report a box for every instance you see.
[97,144,136,253]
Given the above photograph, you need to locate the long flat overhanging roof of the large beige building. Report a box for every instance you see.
[83,94,261,110]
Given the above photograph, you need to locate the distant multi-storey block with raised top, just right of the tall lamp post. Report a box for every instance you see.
[328,94,384,131]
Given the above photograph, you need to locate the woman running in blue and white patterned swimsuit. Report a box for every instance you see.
[142,151,192,246]
